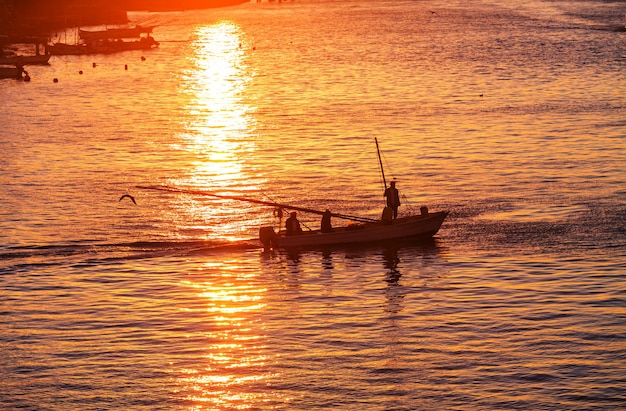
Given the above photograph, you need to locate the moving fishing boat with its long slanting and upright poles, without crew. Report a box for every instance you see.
[137,140,448,249]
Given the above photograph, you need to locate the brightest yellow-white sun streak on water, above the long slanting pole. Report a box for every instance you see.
[181,22,250,188]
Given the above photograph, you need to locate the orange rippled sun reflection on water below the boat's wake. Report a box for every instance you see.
[172,262,276,410]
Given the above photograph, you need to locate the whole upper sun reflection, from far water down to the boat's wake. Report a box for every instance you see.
[167,21,264,240]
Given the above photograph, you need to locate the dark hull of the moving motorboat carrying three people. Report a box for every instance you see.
[262,211,448,248]
